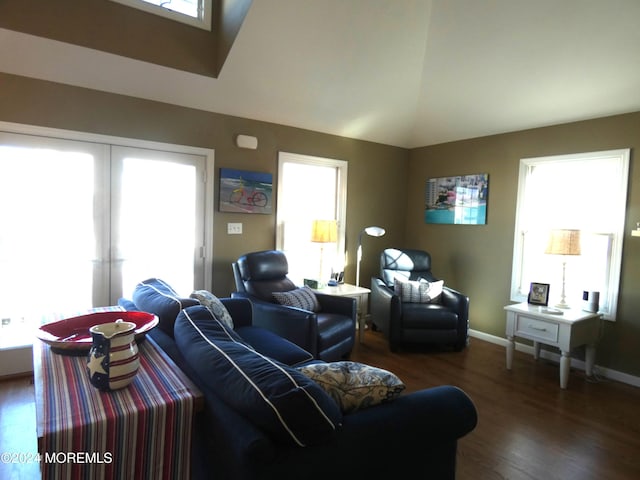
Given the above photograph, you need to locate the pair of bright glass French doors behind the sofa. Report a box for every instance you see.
[0,127,213,349]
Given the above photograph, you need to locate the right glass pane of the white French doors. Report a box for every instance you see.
[111,147,204,301]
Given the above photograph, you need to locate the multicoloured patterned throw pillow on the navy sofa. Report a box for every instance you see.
[298,361,405,413]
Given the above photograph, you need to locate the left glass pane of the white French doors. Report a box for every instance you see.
[0,133,101,348]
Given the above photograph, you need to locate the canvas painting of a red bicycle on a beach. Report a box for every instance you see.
[220,168,273,214]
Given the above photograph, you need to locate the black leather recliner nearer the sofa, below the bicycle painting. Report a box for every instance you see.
[231,250,356,362]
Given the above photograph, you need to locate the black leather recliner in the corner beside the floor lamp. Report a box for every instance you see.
[370,248,469,351]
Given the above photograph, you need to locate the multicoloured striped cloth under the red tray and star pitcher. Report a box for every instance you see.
[39,338,199,480]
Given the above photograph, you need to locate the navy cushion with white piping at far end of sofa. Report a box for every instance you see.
[133,278,198,336]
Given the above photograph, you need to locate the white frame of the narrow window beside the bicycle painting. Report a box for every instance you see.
[276,152,348,281]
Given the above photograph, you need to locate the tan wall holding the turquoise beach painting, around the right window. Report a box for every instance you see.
[405,113,640,376]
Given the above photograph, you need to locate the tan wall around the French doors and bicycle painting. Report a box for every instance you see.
[0,73,408,296]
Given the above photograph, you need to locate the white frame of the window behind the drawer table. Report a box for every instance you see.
[511,149,630,321]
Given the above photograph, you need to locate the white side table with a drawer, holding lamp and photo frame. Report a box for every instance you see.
[504,303,602,388]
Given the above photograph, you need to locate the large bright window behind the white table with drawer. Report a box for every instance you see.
[511,149,629,320]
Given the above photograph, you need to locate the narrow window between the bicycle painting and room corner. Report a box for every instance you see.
[276,152,347,285]
